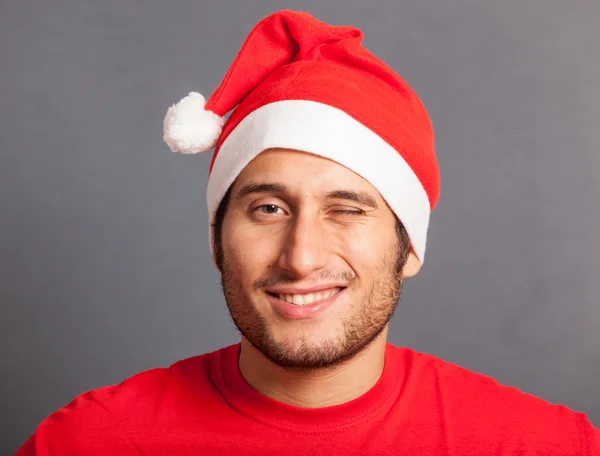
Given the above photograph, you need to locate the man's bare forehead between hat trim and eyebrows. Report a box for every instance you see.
[233,149,381,198]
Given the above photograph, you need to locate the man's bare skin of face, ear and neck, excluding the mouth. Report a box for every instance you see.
[221,149,420,407]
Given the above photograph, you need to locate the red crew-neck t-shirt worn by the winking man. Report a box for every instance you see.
[16,344,600,456]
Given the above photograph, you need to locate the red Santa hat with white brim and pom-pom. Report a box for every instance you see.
[164,11,440,262]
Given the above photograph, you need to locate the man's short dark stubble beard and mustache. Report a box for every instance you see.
[221,242,403,370]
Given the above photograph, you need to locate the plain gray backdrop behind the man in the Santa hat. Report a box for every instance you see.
[0,0,600,454]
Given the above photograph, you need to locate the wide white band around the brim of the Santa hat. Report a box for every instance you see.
[207,100,431,263]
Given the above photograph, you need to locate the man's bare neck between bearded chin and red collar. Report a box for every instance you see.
[239,328,387,408]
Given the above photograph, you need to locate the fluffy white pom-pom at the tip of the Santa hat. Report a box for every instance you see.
[163,92,225,154]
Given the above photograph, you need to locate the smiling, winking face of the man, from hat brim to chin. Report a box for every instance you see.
[221,150,416,369]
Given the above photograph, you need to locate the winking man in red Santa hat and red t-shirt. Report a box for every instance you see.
[17,11,600,456]
